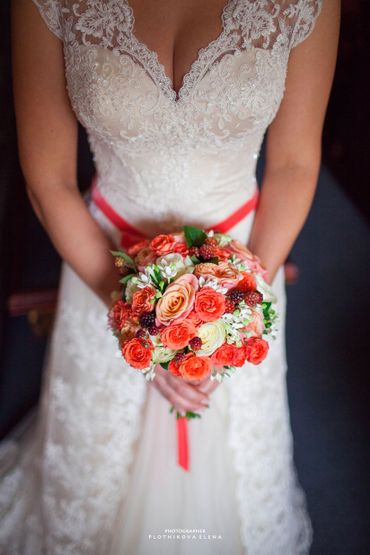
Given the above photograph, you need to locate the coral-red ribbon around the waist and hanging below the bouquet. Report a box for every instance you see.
[91,176,259,470]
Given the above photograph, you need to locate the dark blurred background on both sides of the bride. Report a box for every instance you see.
[0,0,370,555]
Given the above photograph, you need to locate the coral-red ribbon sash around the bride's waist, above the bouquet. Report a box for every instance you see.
[91,176,259,248]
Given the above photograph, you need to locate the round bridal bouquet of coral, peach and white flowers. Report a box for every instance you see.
[109,226,277,394]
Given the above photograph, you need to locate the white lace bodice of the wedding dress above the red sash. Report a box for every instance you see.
[33,0,321,232]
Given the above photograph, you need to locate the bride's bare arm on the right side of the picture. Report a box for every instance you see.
[248,0,340,283]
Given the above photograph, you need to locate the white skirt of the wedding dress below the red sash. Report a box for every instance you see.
[0,198,310,555]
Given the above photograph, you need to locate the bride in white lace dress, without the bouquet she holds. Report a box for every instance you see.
[0,0,339,555]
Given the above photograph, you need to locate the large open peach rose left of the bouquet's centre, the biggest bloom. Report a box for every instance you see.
[156,274,199,326]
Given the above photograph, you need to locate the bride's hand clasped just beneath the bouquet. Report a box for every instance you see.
[150,365,209,413]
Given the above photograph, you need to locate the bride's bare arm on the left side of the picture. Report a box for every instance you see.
[11,0,117,305]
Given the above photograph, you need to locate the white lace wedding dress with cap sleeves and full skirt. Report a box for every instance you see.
[0,0,321,555]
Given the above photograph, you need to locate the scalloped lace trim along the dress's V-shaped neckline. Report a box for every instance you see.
[125,0,234,104]
